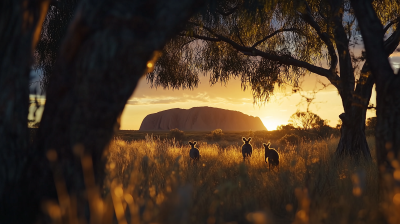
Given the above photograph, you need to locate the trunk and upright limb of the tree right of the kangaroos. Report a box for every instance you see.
[331,1,373,160]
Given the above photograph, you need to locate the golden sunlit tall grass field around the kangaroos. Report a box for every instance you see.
[98,135,386,224]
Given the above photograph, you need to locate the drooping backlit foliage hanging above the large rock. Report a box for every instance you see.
[147,1,310,101]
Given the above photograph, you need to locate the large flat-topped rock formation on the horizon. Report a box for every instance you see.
[139,107,266,131]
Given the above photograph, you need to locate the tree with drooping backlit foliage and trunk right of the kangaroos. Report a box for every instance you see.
[147,0,400,159]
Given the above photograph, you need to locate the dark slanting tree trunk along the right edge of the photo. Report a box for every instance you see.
[351,0,400,223]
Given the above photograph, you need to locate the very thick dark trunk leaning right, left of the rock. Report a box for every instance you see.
[33,0,204,220]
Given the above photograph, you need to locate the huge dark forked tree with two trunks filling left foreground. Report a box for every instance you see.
[0,0,205,223]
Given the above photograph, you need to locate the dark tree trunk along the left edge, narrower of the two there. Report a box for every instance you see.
[0,0,49,223]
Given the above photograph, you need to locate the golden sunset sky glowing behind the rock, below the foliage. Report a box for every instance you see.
[121,53,400,130]
